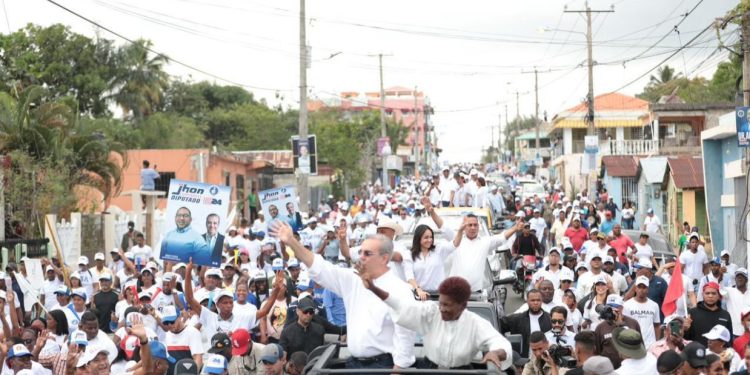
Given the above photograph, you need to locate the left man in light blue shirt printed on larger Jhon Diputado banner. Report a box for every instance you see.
[161,207,213,267]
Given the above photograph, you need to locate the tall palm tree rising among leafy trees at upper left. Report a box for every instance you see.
[109,40,169,119]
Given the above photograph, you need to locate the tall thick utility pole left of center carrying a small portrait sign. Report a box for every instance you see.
[292,0,309,212]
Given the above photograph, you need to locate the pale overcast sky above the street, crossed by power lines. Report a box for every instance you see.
[0,0,738,162]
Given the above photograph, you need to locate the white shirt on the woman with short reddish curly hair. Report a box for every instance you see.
[385,295,513,369]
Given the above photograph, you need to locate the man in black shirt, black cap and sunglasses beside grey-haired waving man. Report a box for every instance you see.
[279,297,325,354]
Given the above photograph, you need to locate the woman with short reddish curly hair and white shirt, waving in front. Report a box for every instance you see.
[357,274,513,369]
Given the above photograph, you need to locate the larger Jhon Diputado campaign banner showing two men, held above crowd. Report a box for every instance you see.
[160,180,232,267]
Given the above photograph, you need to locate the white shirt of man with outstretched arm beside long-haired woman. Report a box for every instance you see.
[449,233,508,291]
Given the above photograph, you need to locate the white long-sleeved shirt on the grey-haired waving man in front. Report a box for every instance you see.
[309,254,415,367]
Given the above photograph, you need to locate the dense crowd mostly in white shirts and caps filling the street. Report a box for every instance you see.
[0,165,750,375]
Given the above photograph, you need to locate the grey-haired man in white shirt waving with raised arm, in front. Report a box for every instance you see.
[270,222,415,368]
